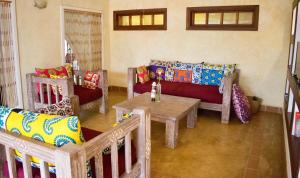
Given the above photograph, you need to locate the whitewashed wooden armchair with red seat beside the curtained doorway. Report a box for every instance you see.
[26,70,108,115]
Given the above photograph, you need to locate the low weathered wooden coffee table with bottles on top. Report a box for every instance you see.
[113,93,200,149]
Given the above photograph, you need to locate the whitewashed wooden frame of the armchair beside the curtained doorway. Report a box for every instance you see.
[26,70,108,115]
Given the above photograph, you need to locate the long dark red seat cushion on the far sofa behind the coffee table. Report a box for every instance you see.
[133,80,223,104]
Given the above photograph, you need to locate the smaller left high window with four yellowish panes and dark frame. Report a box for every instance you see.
[114,9,167,30]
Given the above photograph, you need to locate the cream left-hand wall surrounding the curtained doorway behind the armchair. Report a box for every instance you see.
[16,0,109,107]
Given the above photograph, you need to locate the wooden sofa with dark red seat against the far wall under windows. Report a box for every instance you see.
[127,68,240,124]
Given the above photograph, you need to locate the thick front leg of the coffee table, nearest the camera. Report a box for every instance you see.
[166,120,179,149]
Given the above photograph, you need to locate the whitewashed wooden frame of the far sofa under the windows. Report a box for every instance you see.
[127,67,240,124]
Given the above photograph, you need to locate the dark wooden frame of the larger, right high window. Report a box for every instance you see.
[186,5,259,31]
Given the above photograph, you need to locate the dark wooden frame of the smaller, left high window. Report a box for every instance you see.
[113,8,167,30]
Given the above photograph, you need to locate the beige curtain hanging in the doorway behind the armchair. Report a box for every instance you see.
[64,10,102,70]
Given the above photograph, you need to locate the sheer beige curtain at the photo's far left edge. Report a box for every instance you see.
[0,2,18,107]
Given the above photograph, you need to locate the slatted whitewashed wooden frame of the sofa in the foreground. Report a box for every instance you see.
[0,108,151,178]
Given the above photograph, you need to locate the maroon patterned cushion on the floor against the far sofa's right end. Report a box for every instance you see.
[232,84,251,123]
